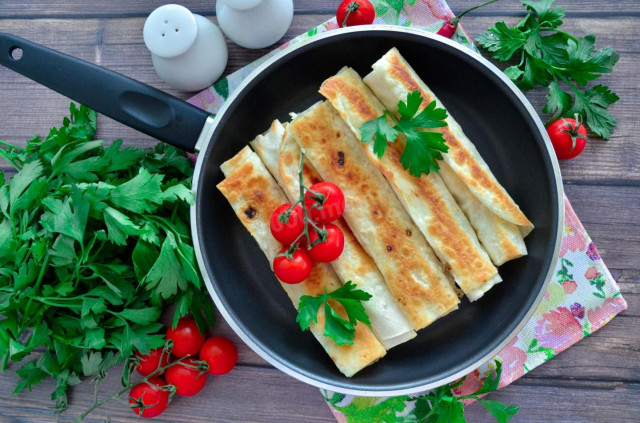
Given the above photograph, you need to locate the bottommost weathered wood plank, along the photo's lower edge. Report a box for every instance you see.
[0,358,640,423]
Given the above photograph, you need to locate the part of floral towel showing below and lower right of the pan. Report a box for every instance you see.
[323,197,627,423]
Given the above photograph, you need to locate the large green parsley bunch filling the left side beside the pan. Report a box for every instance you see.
[0,104,214,411]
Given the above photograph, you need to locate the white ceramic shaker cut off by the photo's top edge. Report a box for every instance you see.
[216,0,293,48]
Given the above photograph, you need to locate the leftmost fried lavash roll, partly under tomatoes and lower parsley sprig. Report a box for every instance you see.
[218,147,386,377]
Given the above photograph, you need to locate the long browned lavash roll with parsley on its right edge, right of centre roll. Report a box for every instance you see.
[320,67,502,301]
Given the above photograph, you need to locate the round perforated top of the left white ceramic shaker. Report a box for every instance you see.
[142,4,198,58]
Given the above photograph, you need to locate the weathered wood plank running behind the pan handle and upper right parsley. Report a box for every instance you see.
[0,15,640,185]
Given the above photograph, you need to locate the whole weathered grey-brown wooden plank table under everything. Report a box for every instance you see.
[0,0,640,423]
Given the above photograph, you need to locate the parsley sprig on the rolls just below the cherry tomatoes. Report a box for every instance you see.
[296,281,371,345]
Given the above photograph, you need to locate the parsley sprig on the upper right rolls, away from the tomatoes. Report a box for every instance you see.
[360,90,449,177]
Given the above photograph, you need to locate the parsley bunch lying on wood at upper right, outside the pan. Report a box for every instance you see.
[476,0,620,140]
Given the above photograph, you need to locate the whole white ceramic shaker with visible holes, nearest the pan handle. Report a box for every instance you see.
[143,4,228,91]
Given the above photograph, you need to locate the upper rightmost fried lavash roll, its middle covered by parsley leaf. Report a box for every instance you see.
[364,48,533,238]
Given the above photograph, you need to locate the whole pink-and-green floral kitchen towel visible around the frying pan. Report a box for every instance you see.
[189,0,627,423]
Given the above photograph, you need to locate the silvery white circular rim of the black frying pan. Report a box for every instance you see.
[191,25,564,396]
